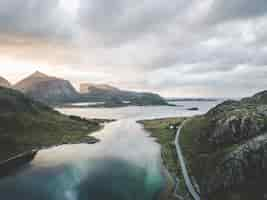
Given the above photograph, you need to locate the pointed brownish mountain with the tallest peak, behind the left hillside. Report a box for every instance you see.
[14,71,79,104]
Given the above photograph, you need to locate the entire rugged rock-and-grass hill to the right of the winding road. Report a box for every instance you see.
[180,91,267,200]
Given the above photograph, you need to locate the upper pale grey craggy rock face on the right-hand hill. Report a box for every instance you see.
[207,101,266,145]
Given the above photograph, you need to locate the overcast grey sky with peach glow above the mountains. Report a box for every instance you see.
[0,0,267,97]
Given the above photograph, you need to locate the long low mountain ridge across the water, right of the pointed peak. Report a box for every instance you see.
[81,84,167,106]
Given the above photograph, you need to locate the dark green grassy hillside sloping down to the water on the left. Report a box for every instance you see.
[0,87,101,161]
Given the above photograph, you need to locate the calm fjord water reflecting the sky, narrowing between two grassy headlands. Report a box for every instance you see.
[0,102,218,200]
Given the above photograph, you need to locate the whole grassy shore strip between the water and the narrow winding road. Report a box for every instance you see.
[138,117,191,200]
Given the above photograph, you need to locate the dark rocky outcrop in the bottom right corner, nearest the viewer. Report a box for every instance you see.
[202,134,267,199]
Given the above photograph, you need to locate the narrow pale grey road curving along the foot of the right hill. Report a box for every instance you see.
[175,121,200,200]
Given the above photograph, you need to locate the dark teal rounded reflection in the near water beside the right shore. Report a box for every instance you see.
[78,159,161,200]
